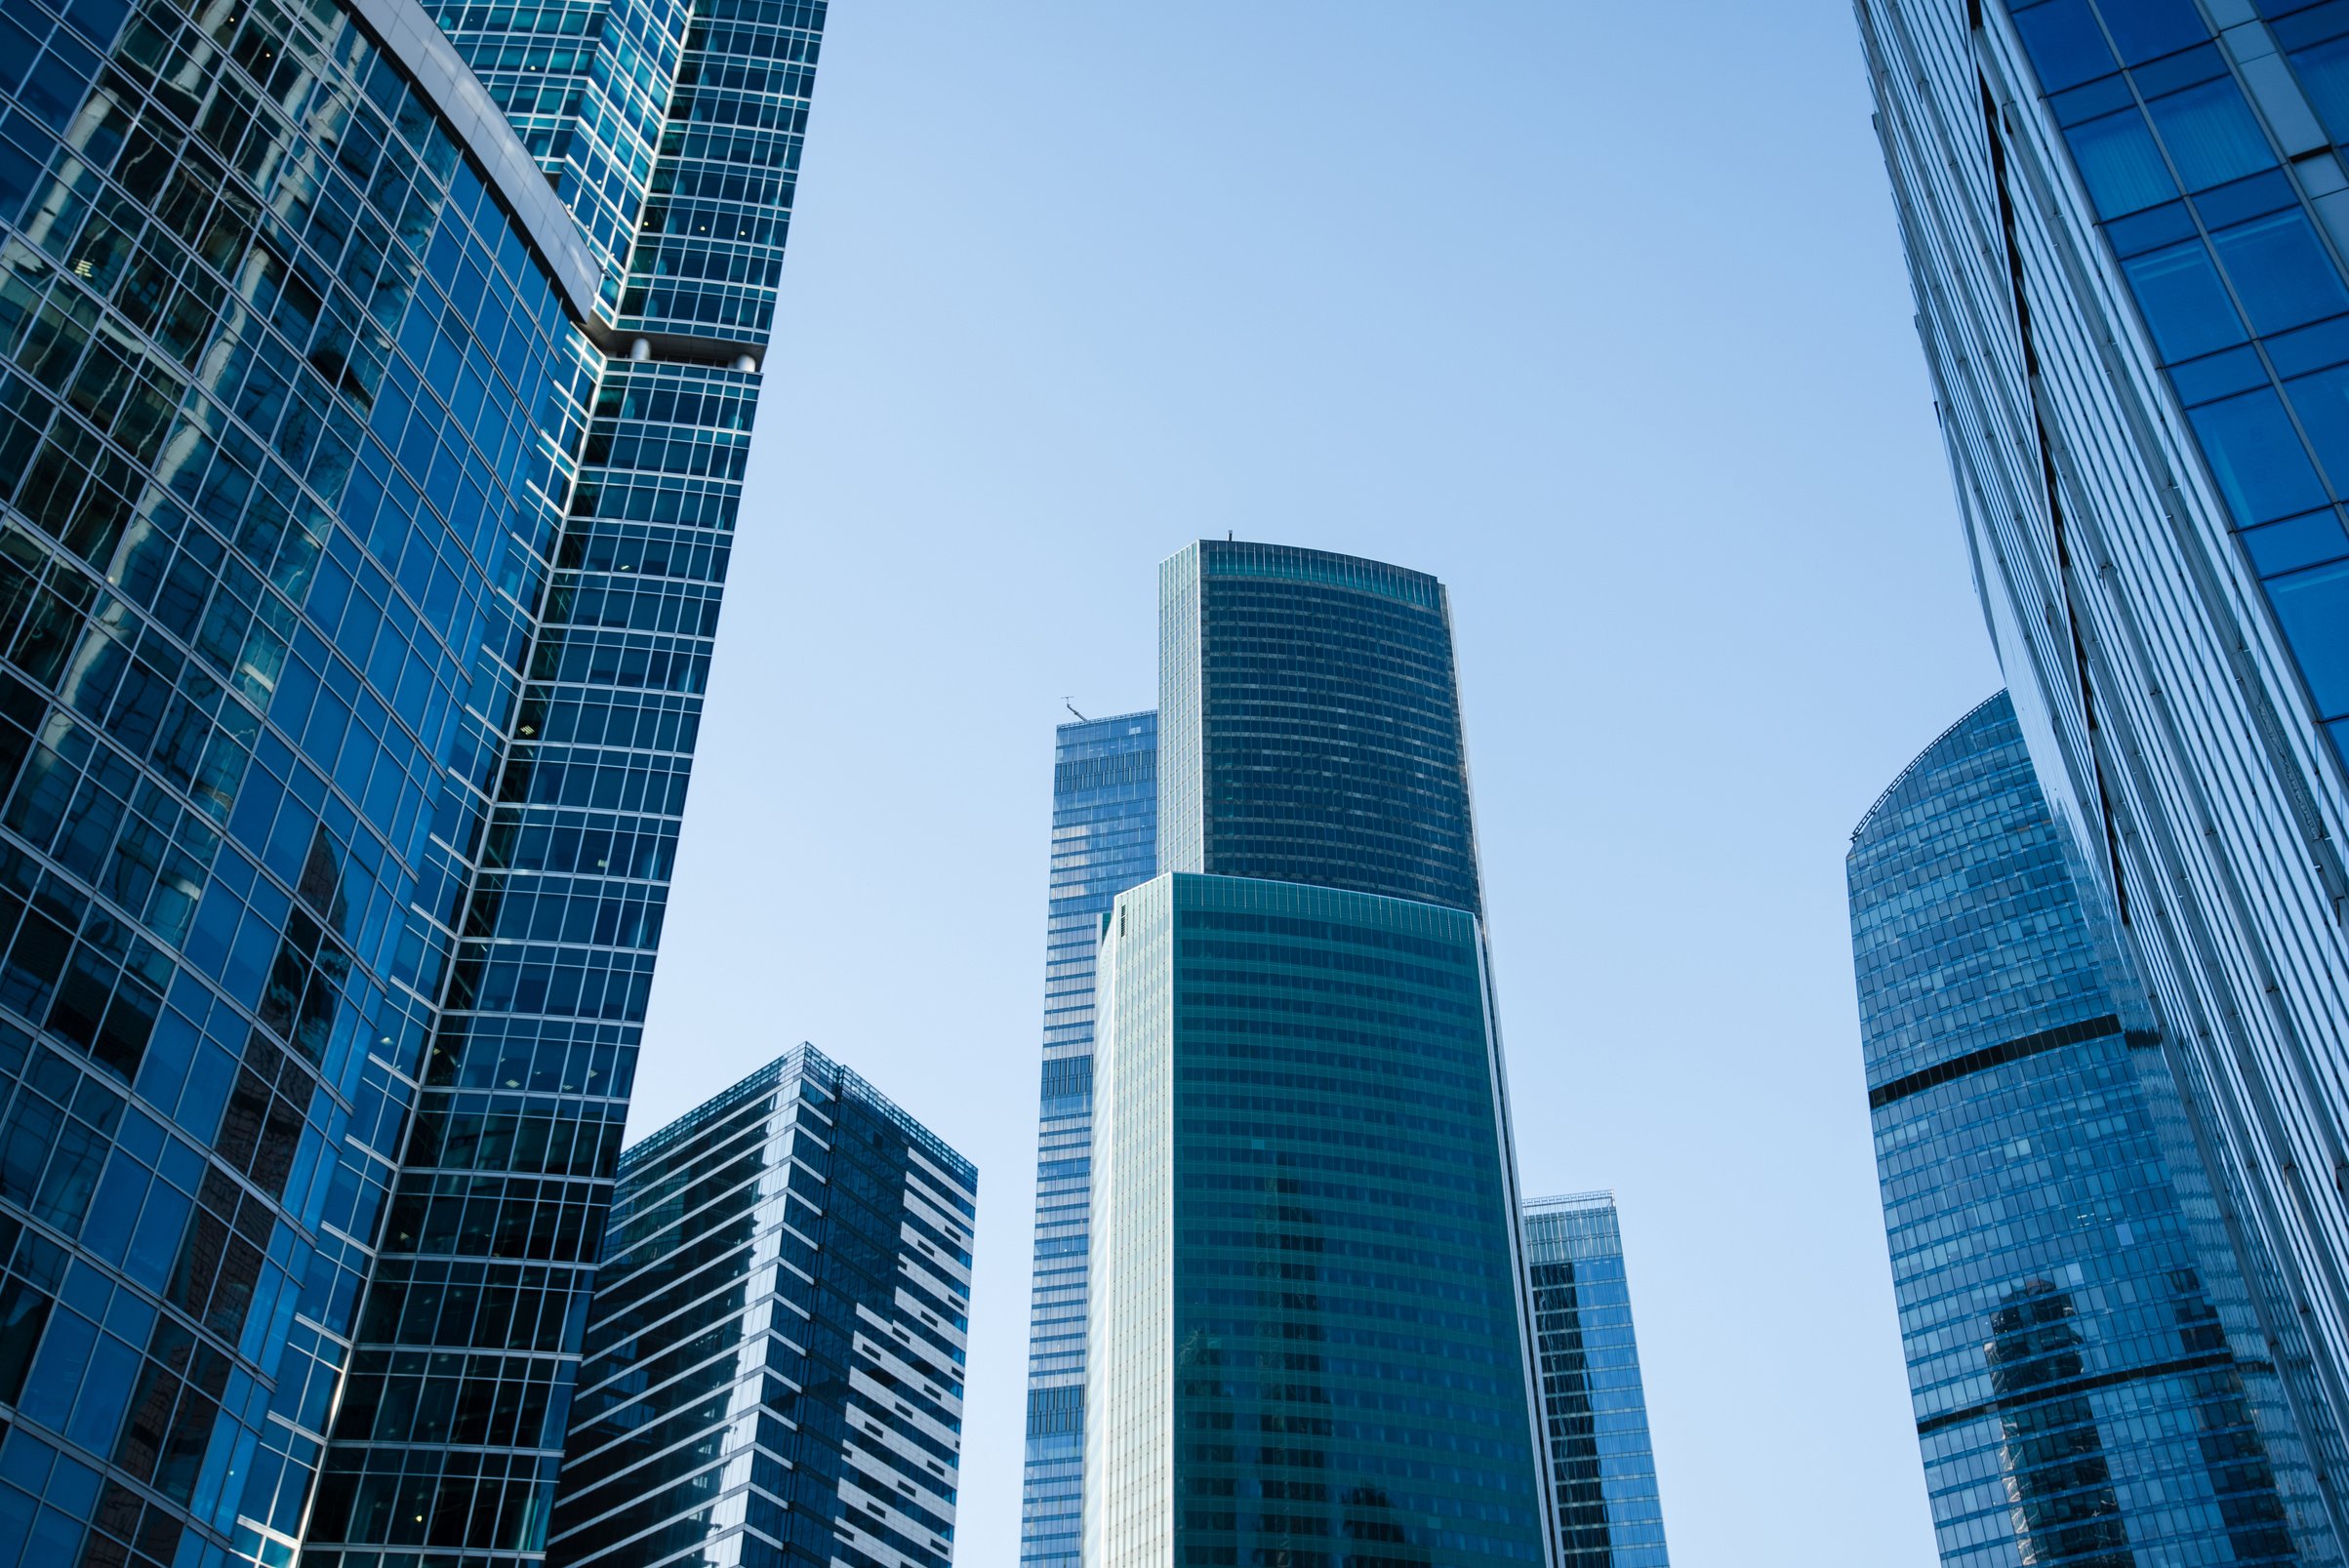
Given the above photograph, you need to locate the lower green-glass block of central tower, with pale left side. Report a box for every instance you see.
[1085,873,1548,1568]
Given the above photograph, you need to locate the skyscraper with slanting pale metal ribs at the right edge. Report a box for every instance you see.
[1858,0,2349,1535]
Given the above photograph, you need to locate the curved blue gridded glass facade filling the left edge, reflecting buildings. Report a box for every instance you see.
[0,5,695,1566]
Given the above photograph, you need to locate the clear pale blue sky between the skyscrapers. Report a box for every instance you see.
[634,0,1999,1568]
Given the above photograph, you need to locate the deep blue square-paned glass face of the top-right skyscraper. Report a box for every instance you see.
[2010,0,2349,756]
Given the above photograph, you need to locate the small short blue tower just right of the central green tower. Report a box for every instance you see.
[1524,1192,1670,1568]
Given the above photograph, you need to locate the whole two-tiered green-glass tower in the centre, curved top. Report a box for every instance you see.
[1083,543,1553,1568]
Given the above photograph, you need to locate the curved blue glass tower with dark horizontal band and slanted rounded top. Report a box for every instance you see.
[1848,695,2342,1568]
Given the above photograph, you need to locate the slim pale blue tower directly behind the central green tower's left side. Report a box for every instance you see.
[1020,713,1158,1568]
